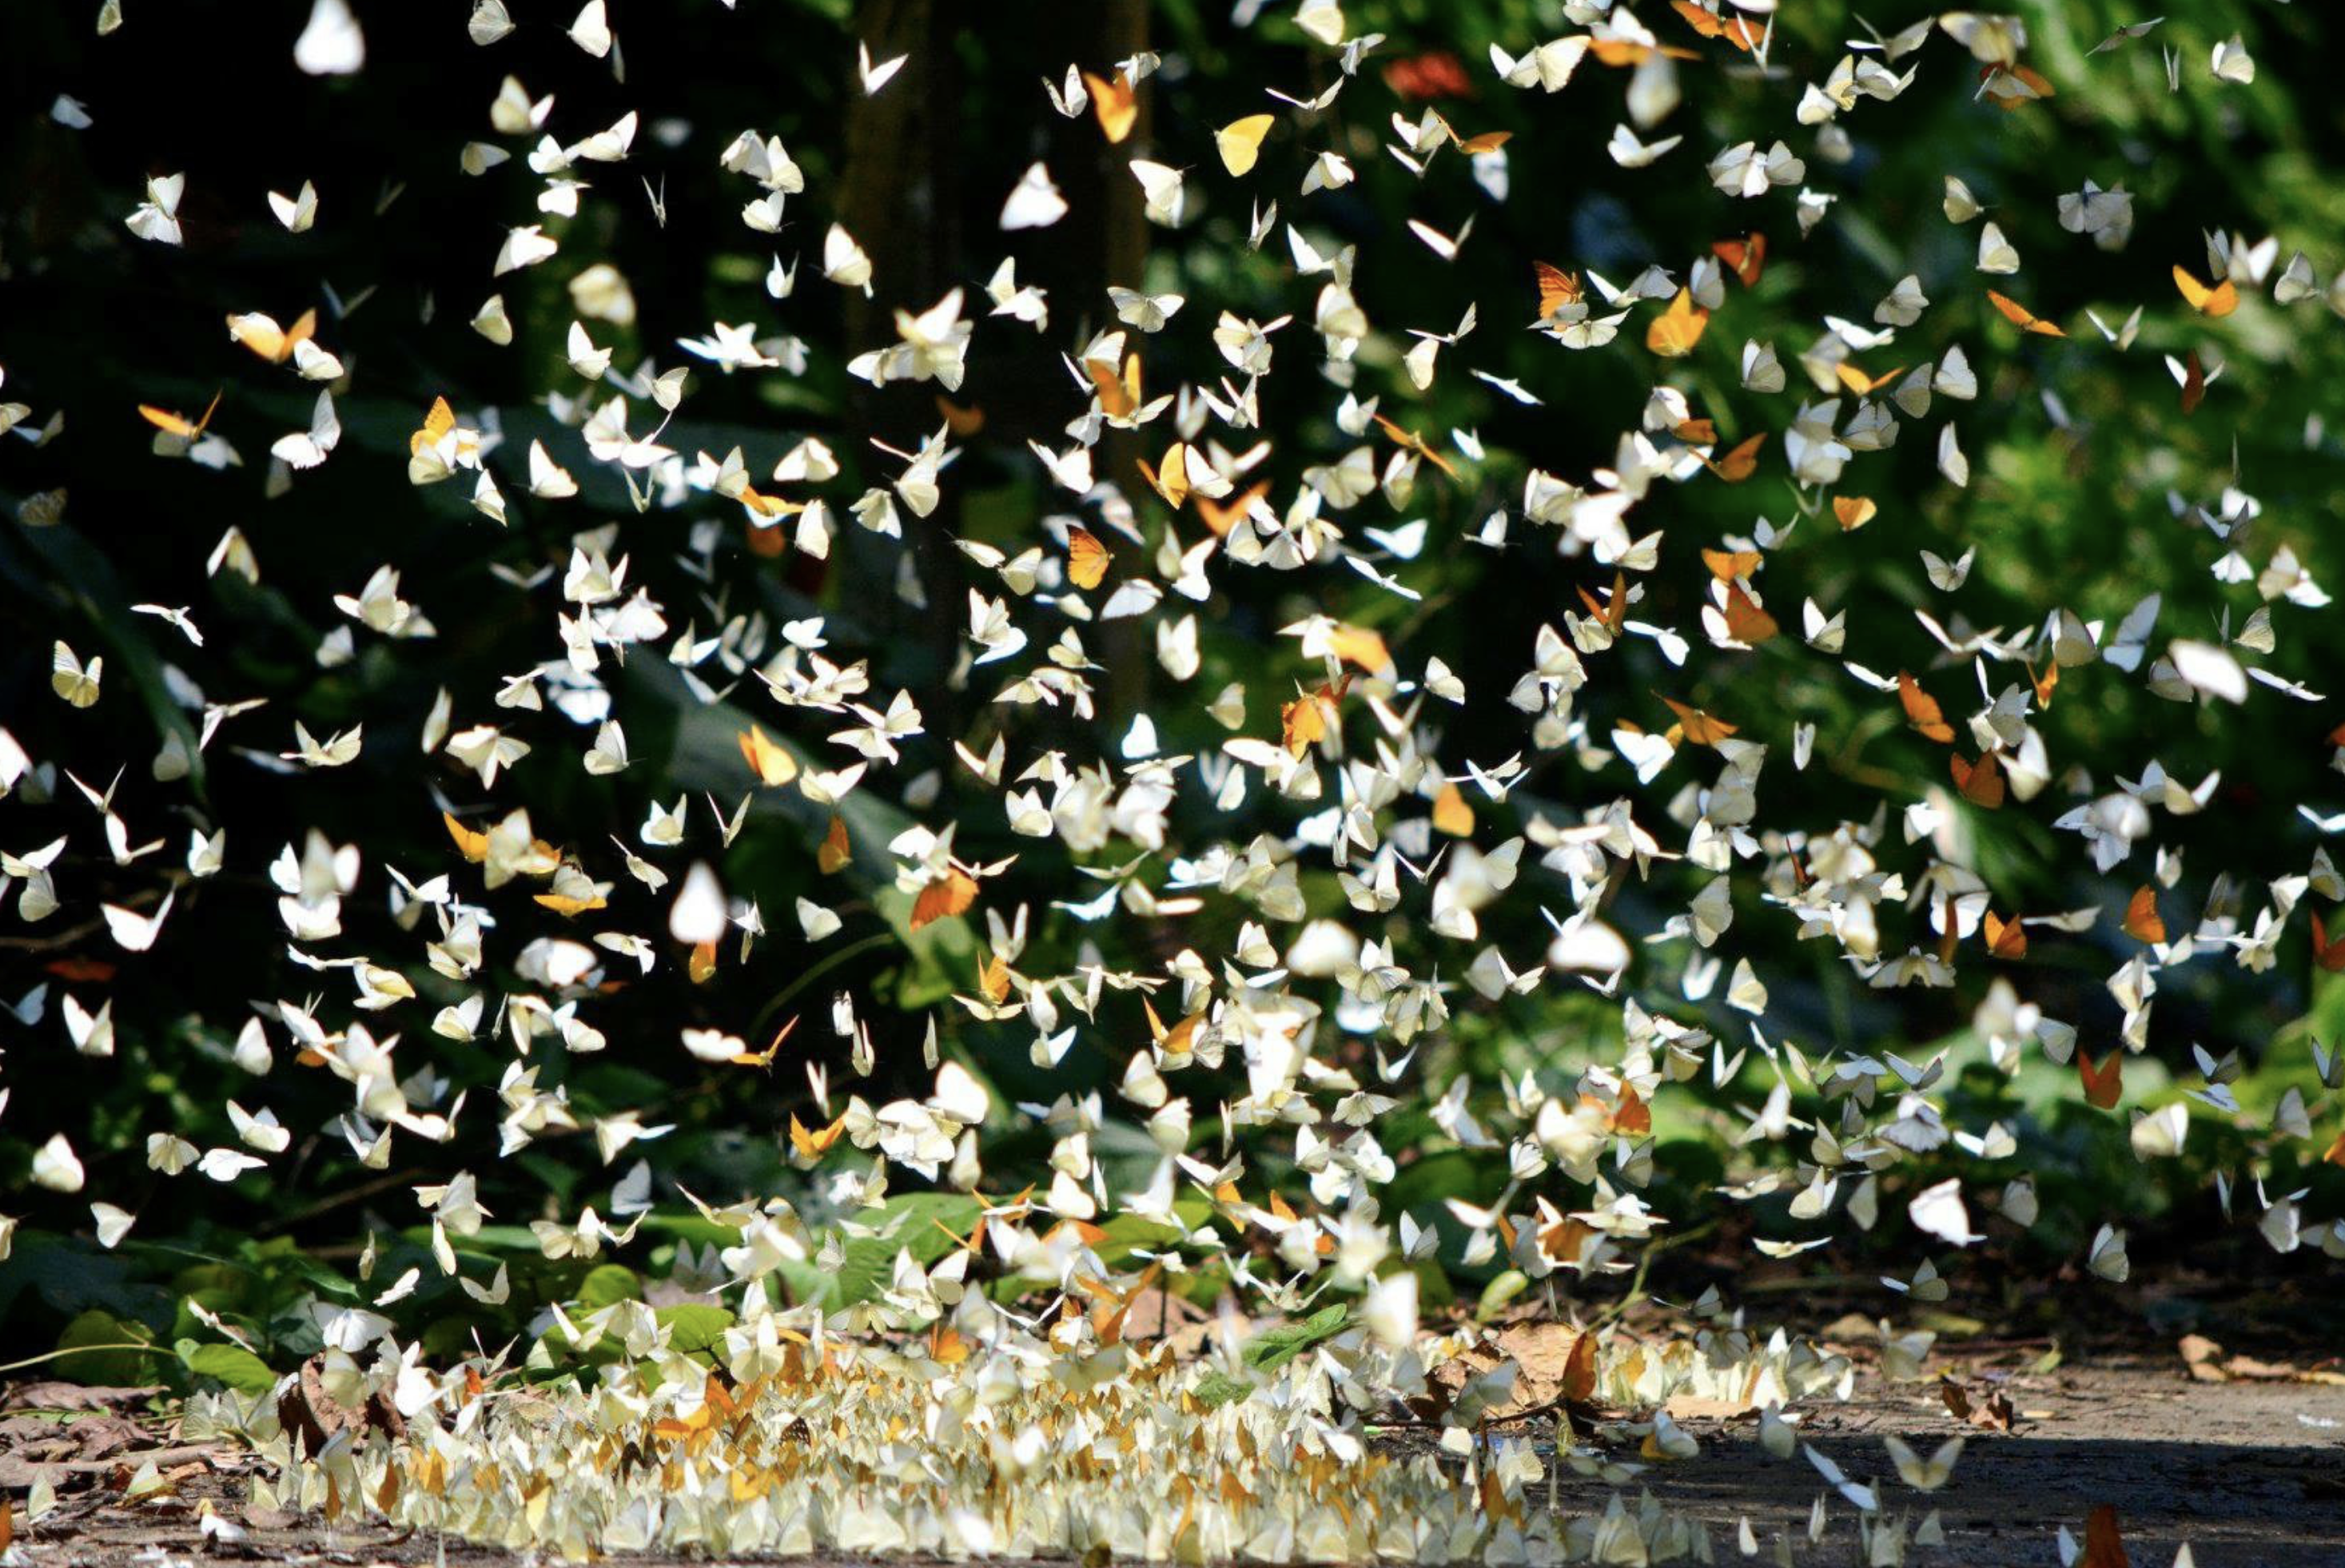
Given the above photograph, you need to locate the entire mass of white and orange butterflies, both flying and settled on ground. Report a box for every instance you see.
[0,0,2345,1568]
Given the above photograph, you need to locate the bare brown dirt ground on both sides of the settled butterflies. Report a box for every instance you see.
[0,1352,2345,1568]
